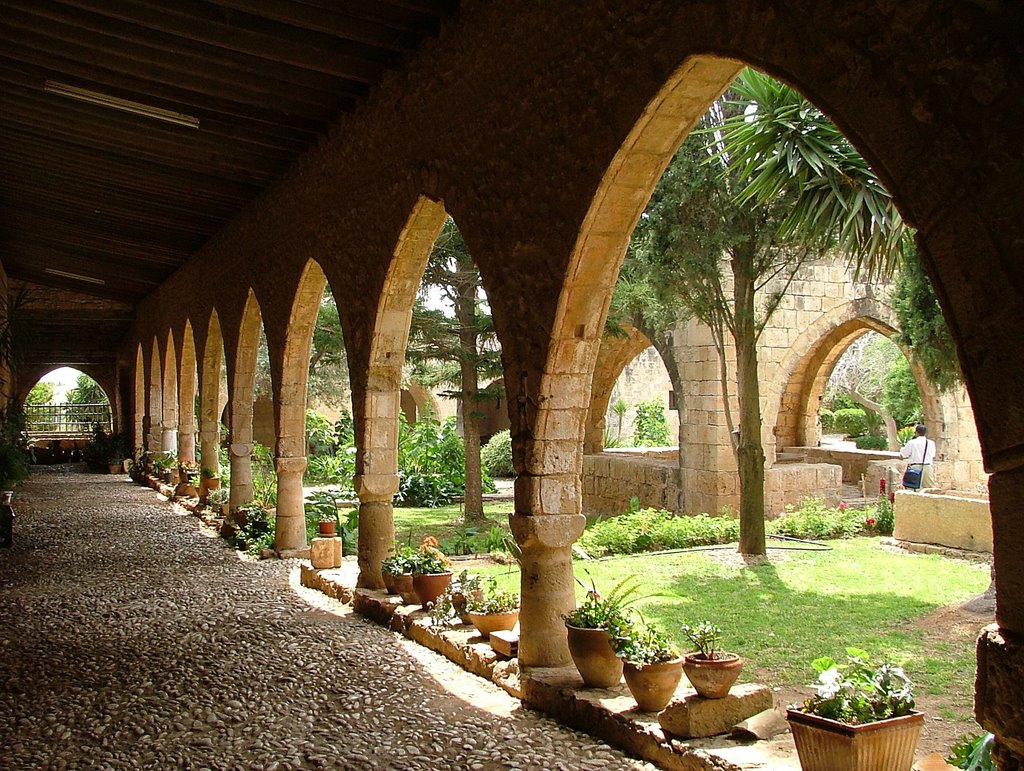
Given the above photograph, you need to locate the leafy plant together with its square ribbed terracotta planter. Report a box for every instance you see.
[786,648,925,771]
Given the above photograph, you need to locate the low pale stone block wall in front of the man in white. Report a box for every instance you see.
[893,490,992,554]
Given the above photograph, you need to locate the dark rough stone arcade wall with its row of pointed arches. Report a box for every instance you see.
[120,0,1024,765]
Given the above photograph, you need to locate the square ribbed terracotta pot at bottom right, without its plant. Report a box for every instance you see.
[785,710,925,771]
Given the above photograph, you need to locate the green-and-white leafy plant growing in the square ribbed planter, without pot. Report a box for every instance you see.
[802,648,913,725]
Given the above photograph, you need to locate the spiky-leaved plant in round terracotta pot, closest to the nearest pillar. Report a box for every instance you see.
[562,575,639,688]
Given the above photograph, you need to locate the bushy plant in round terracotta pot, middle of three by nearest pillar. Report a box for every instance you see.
[611,624,683,712]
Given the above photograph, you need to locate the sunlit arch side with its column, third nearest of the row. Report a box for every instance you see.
[273,260,327,552]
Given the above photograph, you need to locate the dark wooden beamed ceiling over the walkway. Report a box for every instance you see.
[0,0,459,362]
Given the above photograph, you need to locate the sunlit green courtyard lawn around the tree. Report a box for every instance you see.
[481,538,989,720]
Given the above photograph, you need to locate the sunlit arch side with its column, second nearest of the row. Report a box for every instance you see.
[352,196,447,589]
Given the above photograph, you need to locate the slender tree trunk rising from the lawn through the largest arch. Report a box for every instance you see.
[731,247,766,555]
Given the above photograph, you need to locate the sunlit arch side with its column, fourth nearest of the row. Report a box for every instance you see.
[227,289,263,509]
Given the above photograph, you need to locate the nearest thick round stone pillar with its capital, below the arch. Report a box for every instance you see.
[509,475,587,667]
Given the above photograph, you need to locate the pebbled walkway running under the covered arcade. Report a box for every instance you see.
[0,473,651,769]
